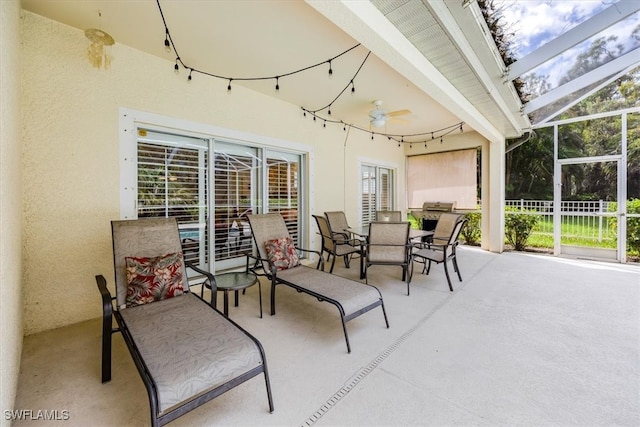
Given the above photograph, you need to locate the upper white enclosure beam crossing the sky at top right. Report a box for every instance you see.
[507,0,640,80]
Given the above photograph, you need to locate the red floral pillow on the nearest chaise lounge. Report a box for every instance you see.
[125,252,185,307]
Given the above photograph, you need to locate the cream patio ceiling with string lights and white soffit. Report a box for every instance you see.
[22,0,530,141]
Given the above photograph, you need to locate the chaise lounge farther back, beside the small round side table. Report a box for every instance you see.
[247,213,389,353]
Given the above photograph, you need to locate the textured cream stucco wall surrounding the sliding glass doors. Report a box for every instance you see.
[22,12,405,334]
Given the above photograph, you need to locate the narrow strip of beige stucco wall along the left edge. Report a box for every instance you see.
[0,0,23,426]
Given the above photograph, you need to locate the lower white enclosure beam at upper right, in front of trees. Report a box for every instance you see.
[524,48,640,114]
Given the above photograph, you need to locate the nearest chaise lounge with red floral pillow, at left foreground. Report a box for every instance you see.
[96,218,273,426]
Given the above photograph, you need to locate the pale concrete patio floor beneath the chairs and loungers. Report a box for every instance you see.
[13,247,640,427]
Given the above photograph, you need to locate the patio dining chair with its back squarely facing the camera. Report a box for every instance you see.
[364,221,411,295]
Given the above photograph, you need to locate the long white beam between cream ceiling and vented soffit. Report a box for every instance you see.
[306,0,505,142]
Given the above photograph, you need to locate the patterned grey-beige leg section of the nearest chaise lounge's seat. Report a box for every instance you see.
[120,292,262,414]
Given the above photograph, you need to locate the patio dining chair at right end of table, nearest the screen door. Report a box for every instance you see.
[412,214,468,292]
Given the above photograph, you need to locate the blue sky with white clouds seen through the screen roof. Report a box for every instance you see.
[495,0,640,87]
